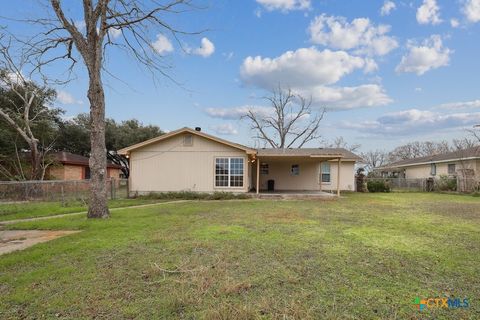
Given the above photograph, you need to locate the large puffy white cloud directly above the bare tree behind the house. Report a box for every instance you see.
[240,48,365,89]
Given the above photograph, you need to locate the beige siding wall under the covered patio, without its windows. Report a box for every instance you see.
[253,158,355,191]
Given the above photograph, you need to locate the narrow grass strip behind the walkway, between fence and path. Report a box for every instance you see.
[0,199,164,221]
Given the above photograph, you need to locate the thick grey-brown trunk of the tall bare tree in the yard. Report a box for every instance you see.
[88,70,110,218]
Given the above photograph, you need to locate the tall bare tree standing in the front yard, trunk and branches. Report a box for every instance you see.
[7,0,199,218]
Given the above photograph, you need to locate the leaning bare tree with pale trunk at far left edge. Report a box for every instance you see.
[0,40,55,180]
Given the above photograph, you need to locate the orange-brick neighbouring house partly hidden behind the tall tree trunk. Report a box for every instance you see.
[46,151,122,180]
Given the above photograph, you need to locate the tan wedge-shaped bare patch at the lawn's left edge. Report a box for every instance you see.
[0,230,80,255]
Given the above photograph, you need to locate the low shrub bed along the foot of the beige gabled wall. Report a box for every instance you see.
[136,191,250,200]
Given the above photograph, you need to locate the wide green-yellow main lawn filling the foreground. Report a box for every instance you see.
[0,193,480,319]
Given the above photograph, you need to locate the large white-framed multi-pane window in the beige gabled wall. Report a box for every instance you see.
[215,158,243,188]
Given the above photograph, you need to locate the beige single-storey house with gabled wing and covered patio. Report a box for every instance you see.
[118,128,360,194]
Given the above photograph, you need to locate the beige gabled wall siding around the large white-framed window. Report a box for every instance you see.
[130,133,249,194]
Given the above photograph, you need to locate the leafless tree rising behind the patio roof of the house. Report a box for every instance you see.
[244,87,325,149]
